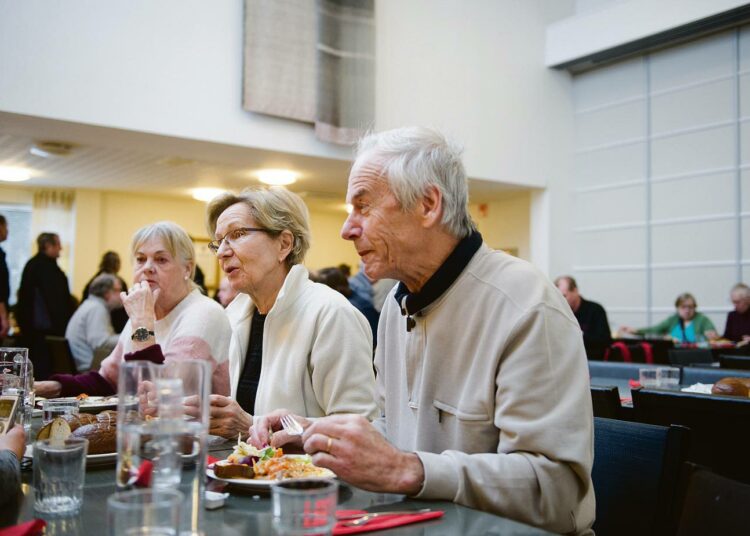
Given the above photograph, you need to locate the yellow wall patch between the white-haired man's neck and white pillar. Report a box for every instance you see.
[469,192,531,260]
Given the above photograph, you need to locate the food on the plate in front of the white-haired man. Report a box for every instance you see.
[213,438,334,480]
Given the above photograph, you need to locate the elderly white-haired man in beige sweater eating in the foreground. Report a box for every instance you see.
[251,128,595,534]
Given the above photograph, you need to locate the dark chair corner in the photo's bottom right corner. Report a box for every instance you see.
[677,463,750,536]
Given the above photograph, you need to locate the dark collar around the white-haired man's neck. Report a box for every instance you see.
[394,230,482,320]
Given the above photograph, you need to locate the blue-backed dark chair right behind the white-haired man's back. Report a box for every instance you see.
[591,417,689,536]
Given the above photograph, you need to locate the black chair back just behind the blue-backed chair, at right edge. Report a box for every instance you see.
[631,389,750,482]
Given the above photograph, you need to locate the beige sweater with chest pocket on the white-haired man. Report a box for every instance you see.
[375,245,595,534]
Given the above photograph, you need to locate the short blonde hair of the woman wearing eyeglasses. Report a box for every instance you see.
[207,187,310,266]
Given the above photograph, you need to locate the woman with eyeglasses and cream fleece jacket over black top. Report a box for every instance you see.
[208,188,376,438]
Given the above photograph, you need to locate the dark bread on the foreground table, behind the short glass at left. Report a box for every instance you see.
[36,411,117,454]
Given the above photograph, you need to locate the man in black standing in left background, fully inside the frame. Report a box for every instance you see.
[16,233,75,379]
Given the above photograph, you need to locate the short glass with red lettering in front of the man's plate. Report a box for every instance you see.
[271,479,339,535]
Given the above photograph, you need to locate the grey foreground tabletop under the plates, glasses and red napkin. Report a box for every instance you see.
[18,432,552,536]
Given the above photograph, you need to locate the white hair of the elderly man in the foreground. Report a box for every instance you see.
[356,127,476,238]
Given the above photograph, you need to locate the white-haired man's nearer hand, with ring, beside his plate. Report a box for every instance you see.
[302,415,424,495]
